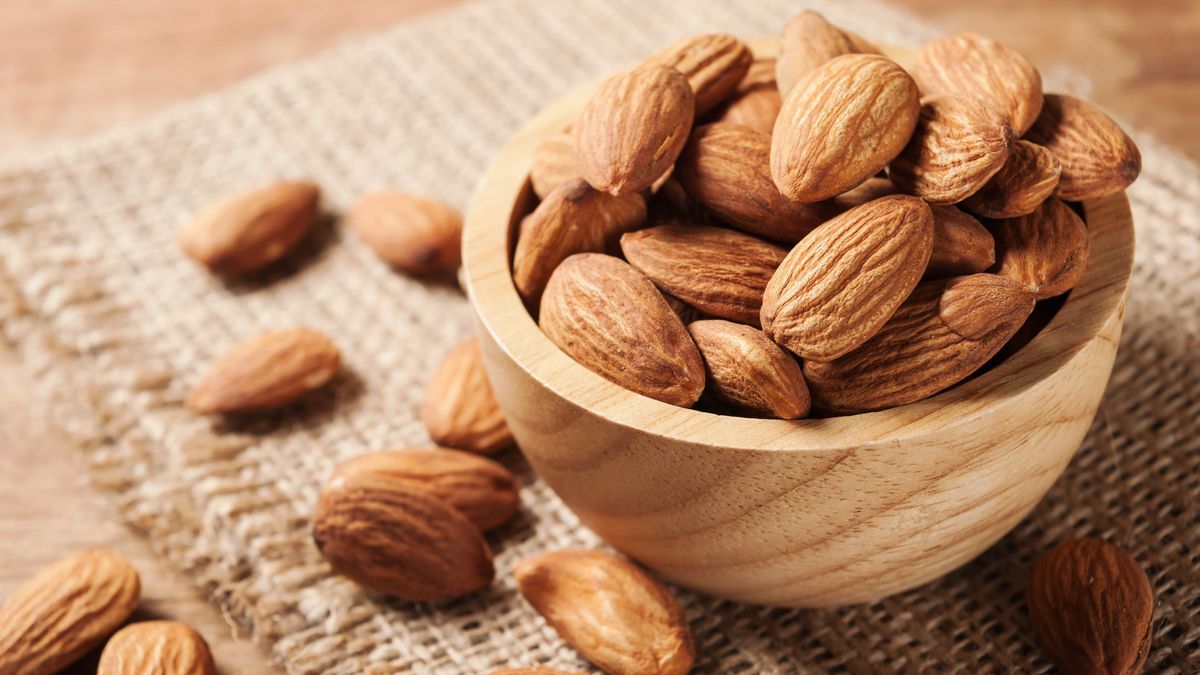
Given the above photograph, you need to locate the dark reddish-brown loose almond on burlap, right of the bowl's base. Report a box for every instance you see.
[1027,538,1154,675]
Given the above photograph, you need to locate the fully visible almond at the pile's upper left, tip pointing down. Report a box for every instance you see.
[575,65,696,195]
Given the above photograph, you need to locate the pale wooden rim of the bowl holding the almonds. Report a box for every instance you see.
[463,38,1134,452]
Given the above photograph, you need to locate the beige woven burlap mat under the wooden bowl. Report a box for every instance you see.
[0,0,1200,674]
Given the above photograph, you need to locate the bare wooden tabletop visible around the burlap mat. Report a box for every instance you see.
[0,0,1200,674]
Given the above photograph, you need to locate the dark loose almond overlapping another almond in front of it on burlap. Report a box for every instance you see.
[312,473,496,602]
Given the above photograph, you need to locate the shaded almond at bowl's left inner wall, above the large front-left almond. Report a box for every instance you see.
[512,178,646,306]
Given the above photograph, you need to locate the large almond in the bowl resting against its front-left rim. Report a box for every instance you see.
[539,253,704,407]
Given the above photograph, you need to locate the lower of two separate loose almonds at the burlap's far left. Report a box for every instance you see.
[187,328,342,414]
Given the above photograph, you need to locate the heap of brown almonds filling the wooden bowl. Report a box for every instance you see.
[512,11,1141,419]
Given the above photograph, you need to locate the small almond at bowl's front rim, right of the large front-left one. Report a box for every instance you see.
[688,321,812,419]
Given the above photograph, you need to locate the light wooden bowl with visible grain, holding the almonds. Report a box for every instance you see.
[463,42,1133,607]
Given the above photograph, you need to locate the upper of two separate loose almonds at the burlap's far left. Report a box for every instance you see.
[179,181,320,275]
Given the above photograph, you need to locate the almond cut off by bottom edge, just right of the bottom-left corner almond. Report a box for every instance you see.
[96,621,217,675]
